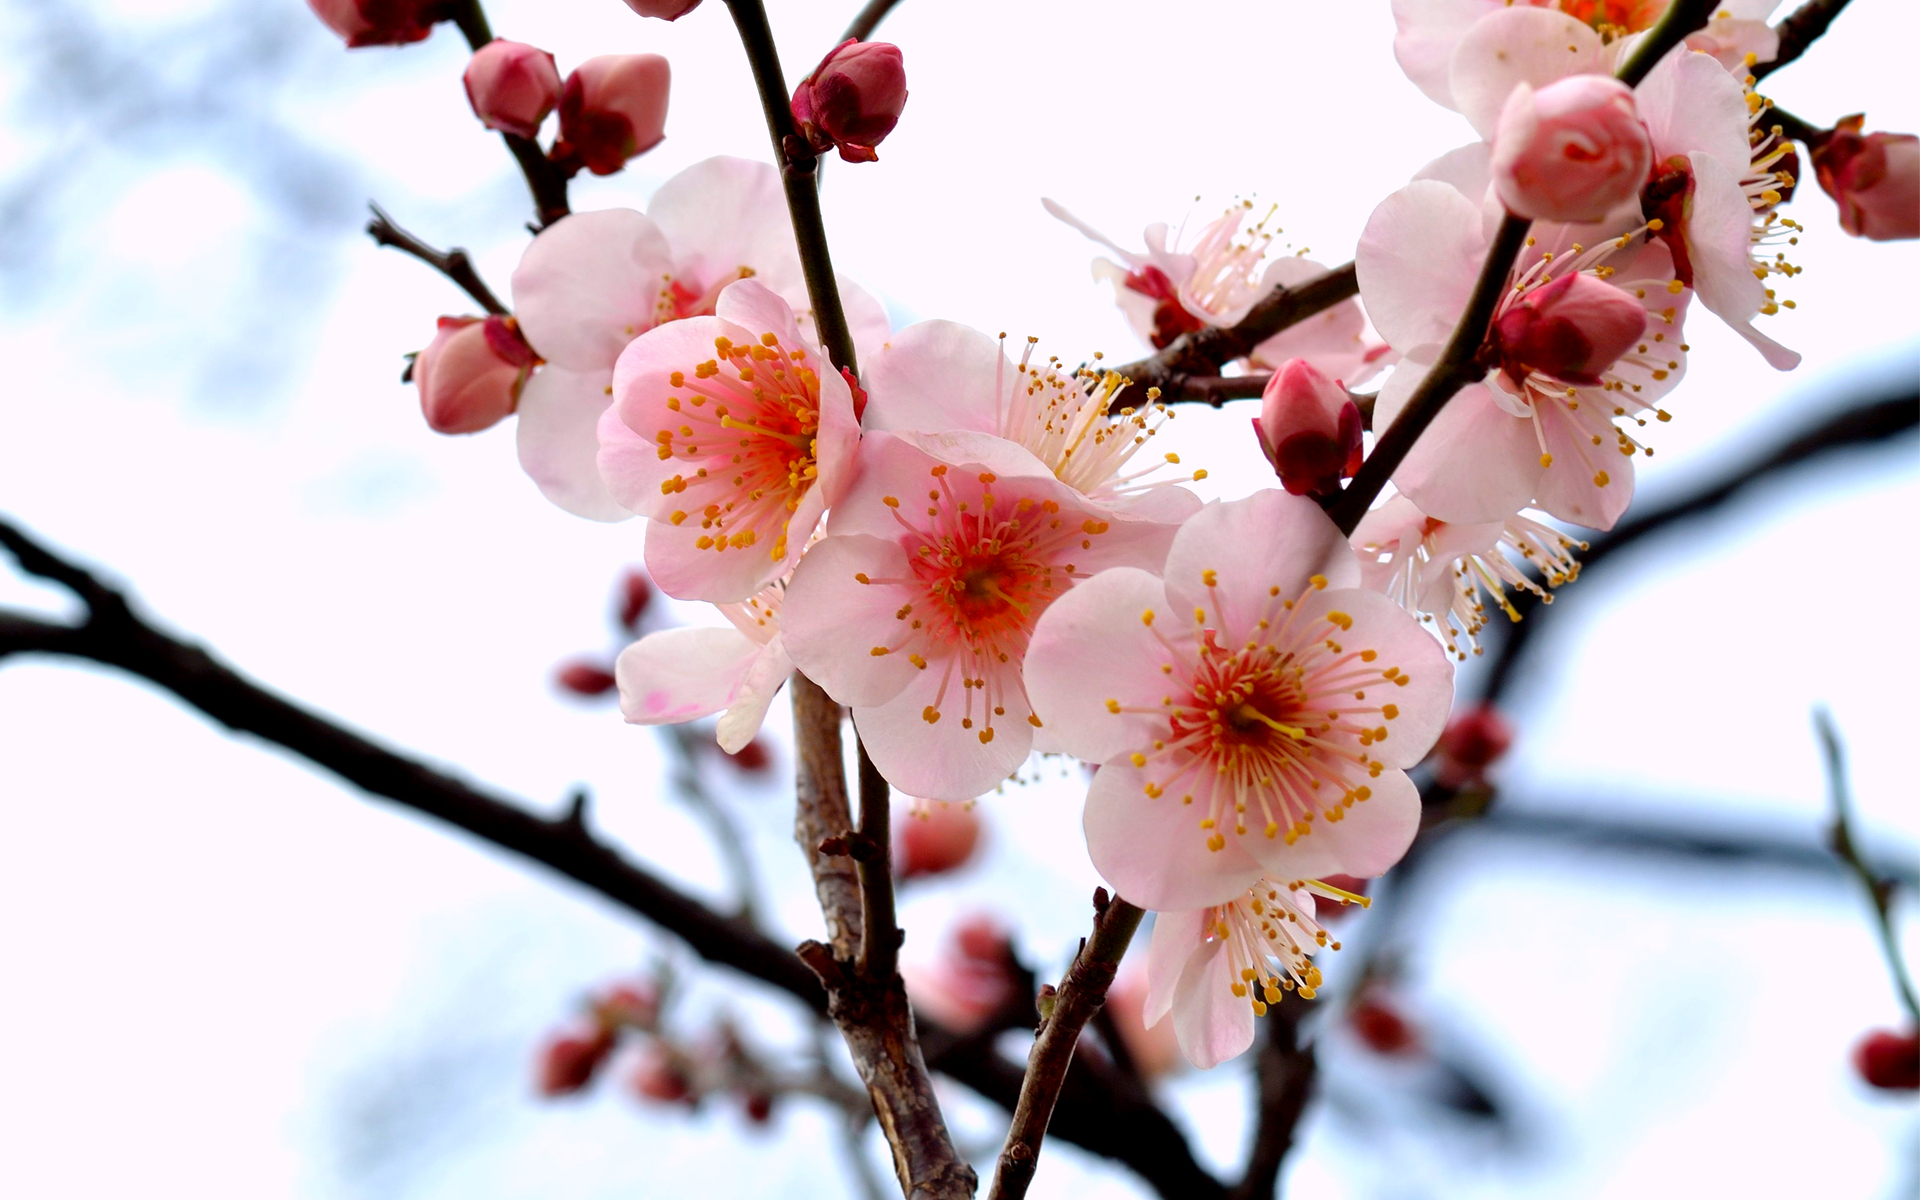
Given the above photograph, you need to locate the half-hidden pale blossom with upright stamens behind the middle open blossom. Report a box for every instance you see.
[862,321,1206,520]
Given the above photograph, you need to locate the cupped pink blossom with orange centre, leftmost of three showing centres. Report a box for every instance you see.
[599,278,856,599]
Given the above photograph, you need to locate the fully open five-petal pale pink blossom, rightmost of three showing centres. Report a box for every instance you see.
[1027,490,1453,912]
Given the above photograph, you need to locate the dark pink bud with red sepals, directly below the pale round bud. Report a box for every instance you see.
[1494,275,1647,386]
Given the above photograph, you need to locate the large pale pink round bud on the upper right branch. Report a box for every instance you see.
[1494,75,1653,221]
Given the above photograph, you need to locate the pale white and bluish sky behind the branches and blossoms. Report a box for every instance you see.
[0,0,1920,1200]
